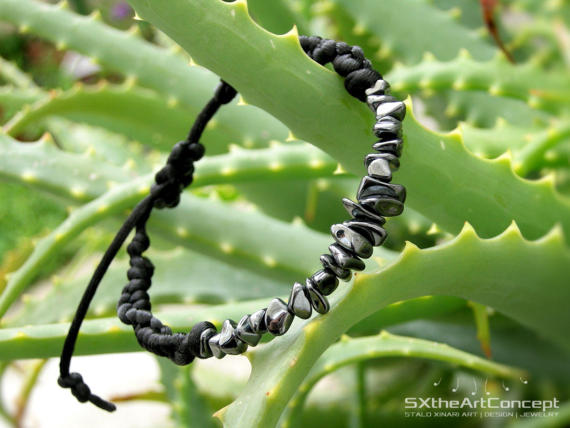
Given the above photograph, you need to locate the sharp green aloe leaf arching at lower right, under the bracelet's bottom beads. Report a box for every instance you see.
[216,222,570,426]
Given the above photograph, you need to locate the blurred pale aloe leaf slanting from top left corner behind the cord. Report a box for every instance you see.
[0,0,287,149]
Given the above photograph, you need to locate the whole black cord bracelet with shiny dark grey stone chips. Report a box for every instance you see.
[58,36,406,411]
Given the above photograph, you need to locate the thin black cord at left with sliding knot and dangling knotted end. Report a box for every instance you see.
[58,81,236,412]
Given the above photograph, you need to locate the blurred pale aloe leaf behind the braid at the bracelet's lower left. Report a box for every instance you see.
[2,248,290,327]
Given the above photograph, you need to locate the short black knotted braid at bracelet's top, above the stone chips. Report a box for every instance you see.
[299,36,382,101]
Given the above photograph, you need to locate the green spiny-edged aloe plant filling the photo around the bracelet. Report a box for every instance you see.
[0,0,570,428]
